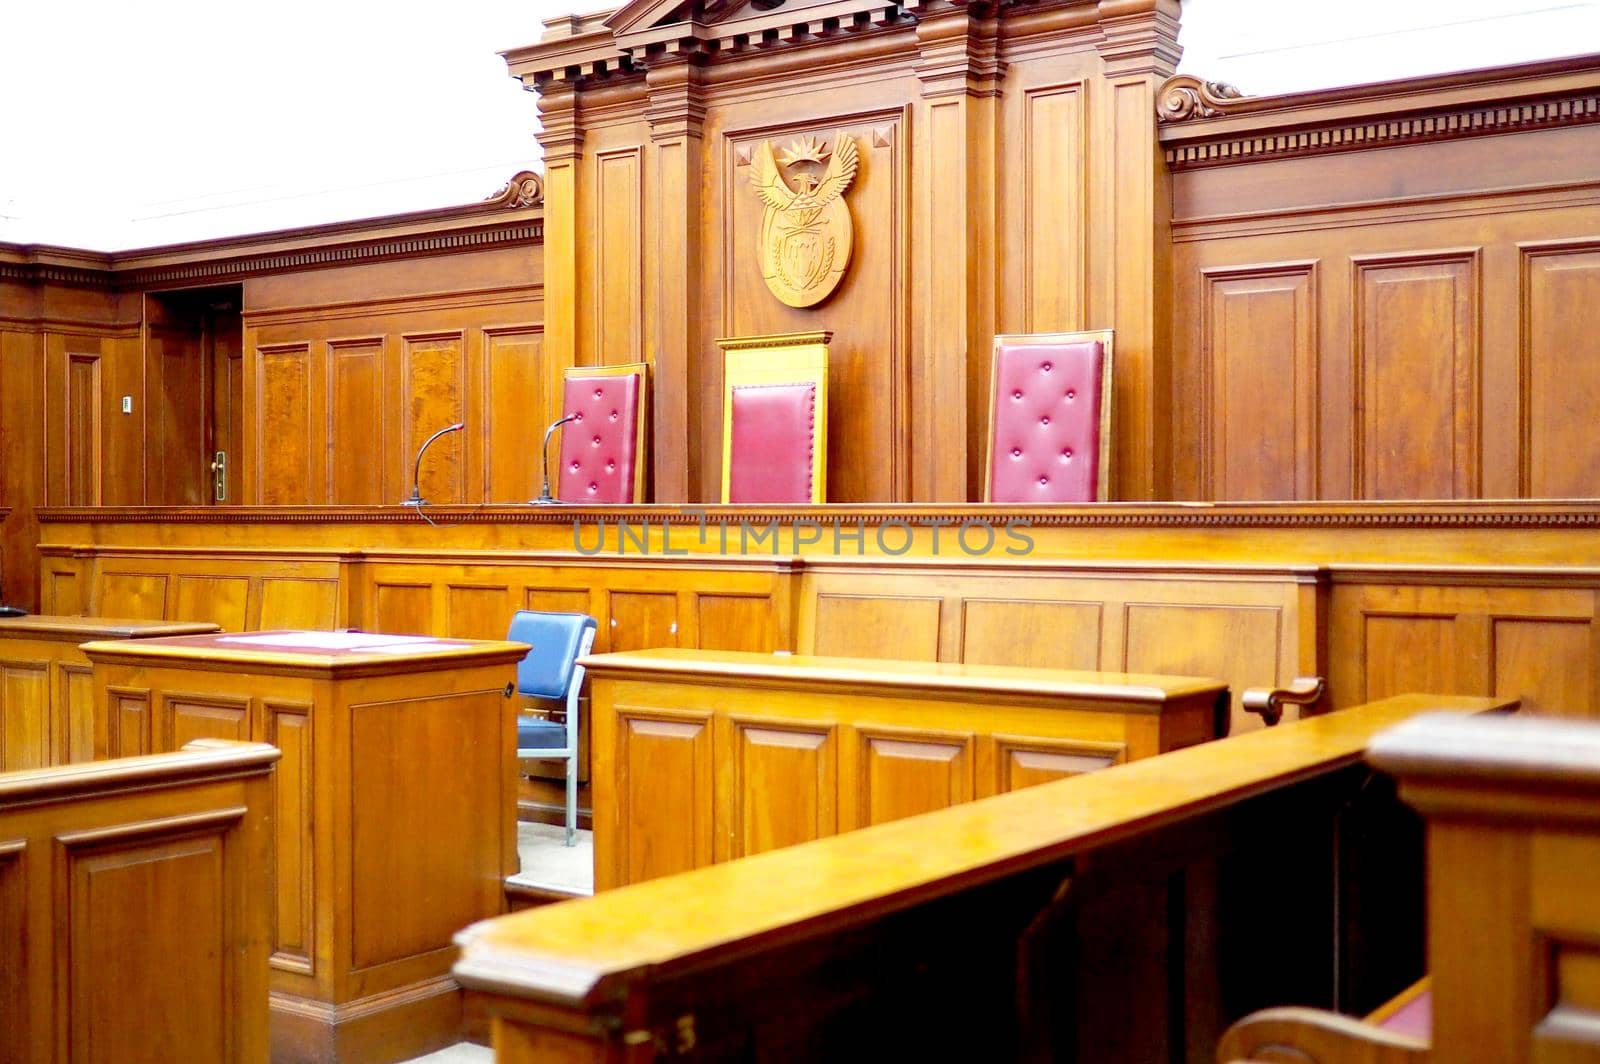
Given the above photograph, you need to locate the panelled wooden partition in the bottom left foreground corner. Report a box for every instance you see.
[0,741,278,1064]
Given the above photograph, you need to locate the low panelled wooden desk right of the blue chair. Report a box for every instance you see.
[584,650,1227,890]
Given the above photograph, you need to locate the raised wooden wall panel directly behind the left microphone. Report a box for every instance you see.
[400,331,467,502]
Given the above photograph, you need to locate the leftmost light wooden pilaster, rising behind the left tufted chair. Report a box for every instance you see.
[539,83,584,444]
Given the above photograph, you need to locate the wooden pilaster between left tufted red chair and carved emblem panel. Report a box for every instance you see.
[643,54,717,502]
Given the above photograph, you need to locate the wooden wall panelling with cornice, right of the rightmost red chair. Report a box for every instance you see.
[1164,58,1600,499]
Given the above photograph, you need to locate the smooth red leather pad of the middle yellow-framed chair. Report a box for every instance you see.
[728,381,816,502]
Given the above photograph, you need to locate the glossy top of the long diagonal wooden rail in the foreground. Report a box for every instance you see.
[454,694,1518,1008]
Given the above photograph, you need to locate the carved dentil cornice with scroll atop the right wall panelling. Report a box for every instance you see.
[1157,56,1600,170]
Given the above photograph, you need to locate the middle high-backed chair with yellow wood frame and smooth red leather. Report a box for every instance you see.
[717,333,832,504]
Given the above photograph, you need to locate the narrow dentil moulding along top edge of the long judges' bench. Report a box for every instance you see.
[37,501,1600,530]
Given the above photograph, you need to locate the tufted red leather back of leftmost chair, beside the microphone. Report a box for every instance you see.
[555,373,640,502]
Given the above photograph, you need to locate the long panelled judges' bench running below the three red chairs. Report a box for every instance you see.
[42,502,1600,731]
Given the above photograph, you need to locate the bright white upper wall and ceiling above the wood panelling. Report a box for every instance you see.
[0,0,1600,251]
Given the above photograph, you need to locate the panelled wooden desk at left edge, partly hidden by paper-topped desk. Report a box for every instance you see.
[0,616,218,771]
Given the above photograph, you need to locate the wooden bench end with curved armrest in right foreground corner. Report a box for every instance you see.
[1218,704,1600,1064]
